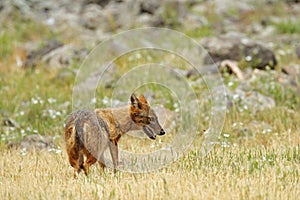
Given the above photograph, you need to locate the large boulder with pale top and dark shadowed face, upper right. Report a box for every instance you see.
[200,34,277,69]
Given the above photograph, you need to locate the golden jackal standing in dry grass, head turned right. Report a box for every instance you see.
[65,94,165,178]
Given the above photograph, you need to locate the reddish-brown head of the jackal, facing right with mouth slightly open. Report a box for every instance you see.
[130,94,165,140]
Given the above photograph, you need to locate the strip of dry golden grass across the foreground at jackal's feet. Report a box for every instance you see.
[0,132,300,199]
